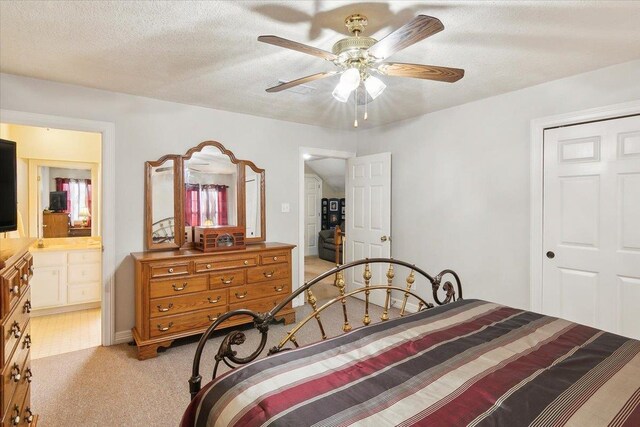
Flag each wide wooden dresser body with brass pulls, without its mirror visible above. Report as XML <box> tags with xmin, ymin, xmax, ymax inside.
<box><xmin>131</xmin><ymin>243</ymin><xmax>295</xmax><ymax>360</ymax></box>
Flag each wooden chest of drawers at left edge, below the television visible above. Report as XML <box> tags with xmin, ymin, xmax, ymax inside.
<box><xmin>0</xmin><ymin>239</ymin><xmax>37</xmax><ymax>426</ymax></box>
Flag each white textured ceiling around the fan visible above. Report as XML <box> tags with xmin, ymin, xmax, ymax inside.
<box><xmin>0</xmin><ymin>0</ymin><xmax>640</xmax><ymax>128</ymax></box>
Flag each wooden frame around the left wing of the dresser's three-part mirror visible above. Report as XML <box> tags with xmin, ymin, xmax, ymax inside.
<box><xmin>144</xmin><ymin>154</ymin><xmax>184</xmax><ymax>250</ymax></box>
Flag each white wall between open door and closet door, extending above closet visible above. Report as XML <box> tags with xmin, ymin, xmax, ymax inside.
<box><xmin>357</xmin><ymin>61</ymin><xmax>640</xmax><ymax>308</ymax></box>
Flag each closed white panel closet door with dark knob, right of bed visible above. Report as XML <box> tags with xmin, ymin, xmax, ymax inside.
<box><xmin>542</xmin><ymin>116</ymin><xmax>640</xmax><ymax>338</ymax></box>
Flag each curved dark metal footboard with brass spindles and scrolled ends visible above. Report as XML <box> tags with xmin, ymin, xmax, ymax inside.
<box><xmin>189</xmin><ymin>258</ymin><xmax>462</xmax><ymax>399</ymax></box>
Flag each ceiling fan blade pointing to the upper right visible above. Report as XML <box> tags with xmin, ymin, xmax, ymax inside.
<box><xmin>369</xmin><ymin>15</ymin><xmax>444</xmax><ymax>59</ymax></box>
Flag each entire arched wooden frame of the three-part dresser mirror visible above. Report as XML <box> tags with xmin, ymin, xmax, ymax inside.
<box><xmin>145</xmin><ymin>140</ymin><xmax>267</xmax><ymax>251</ymax></box>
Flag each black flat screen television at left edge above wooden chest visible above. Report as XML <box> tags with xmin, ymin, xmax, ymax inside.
<box><xmin>0</xmin><ymin>139</ymin><xmax>18</xmax><ymax>233</ymax></box>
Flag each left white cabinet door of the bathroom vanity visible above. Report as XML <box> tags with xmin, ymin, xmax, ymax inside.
<box><xmin>31</xmin><ymin>264</ymin><xmax>67</xmax><ymax>309</ymax></box>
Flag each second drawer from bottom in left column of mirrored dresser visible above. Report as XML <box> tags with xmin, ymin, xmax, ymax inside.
<box><xmin>149</xmin><ymin>289</ymin><xmax>227</xmax><ymax>318</ymax></box>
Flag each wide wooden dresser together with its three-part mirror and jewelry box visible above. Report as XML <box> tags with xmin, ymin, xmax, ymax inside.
<box><xmin>131</xmin><ymin>141</ymin><xmax>295</xmax><ymax>360</ymax></box>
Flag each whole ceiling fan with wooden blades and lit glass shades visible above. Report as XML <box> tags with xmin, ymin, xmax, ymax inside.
<box><xmin>258</xmin><ymin>14</ymin><xmax>464</xmax><ymax>127</ymax></box>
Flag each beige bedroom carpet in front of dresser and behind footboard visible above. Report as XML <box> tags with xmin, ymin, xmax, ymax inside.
<box><xmin>31</xmin><ymin>298</ymin><xmax>397</xmax><ymax>427</ymax></box>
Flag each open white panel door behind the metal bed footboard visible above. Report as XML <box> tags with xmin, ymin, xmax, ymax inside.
<box><xmin>345</xmin><ymin>153</ymin><xmax>391</xmax><ymax>305</ymax></box>
